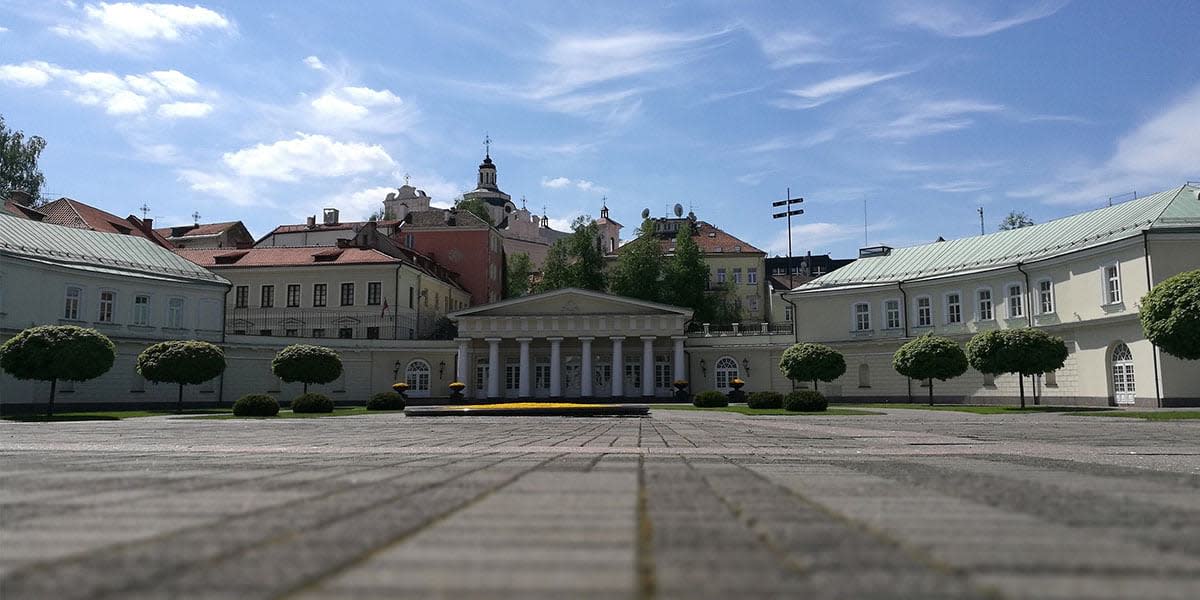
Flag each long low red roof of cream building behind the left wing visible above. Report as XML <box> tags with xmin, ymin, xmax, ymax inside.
<box><xmin>175</xmin><ymin>246</ymin><xmax>403</xmax><ymax>269</ymax></box>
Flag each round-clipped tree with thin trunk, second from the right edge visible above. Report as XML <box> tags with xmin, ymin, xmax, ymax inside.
<box><xmin>967</xmin><ymin>328</ymin><xmax>1069</xmax><ymax>408</ymax></box>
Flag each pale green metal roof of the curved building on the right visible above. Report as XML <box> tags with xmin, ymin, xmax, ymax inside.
<box><xmin>796</xmin><ymin>184</ymin><xmax>1200</xmax><ymax>292</ymax></box>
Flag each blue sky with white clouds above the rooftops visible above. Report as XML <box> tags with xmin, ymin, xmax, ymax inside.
<box><xmin>0</xmin><ymin>0</ymin><xmax>1200</xmax><ymax>256</ymax></box>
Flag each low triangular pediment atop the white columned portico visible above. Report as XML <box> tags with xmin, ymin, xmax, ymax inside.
<box><xmin>450</xmin><ymin>288</ymin><xmax>692</xmax><ymax>319</ymax></box>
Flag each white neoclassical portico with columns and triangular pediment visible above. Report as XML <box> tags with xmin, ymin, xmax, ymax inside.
<box><xmin>450</xmin><ymin>288</ymin><xmax>691</xmax><ymax>398</ymax></box>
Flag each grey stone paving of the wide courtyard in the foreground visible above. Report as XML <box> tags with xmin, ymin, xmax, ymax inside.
<box><xmin>0</xmin><ymin>409</ymin><xmax>1200</xmax><ymax>600</ymax></box>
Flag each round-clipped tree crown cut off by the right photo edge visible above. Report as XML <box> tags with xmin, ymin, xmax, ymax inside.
<box><xmin>1141</xmin><ymin>270</ymin><xmax>1200</xmax><ymax>360</ymax></box>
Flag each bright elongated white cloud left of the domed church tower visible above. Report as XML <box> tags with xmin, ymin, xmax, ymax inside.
<box><xmin>222</xmin><ymin>132</ymin><xmax>395</xmax><ymax>181</ymax></box>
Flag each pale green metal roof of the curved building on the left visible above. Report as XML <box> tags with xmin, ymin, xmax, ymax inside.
<box><xmin>0</xmin><ymin>215</ymin><xmax>229</xmax><ymax>284</ymax></box>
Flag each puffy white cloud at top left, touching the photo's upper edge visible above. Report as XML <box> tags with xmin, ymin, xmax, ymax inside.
<box><xmin>52</xmin><ymin>2</ymin><xmax>233</xmax><ymax>52</ymax></box>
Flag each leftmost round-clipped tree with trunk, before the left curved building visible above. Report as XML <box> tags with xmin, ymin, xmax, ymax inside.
<box><xmin>0</xmin><ymin>325</ymin><xmax>116</xmax><ymax>415</ymax></box>
